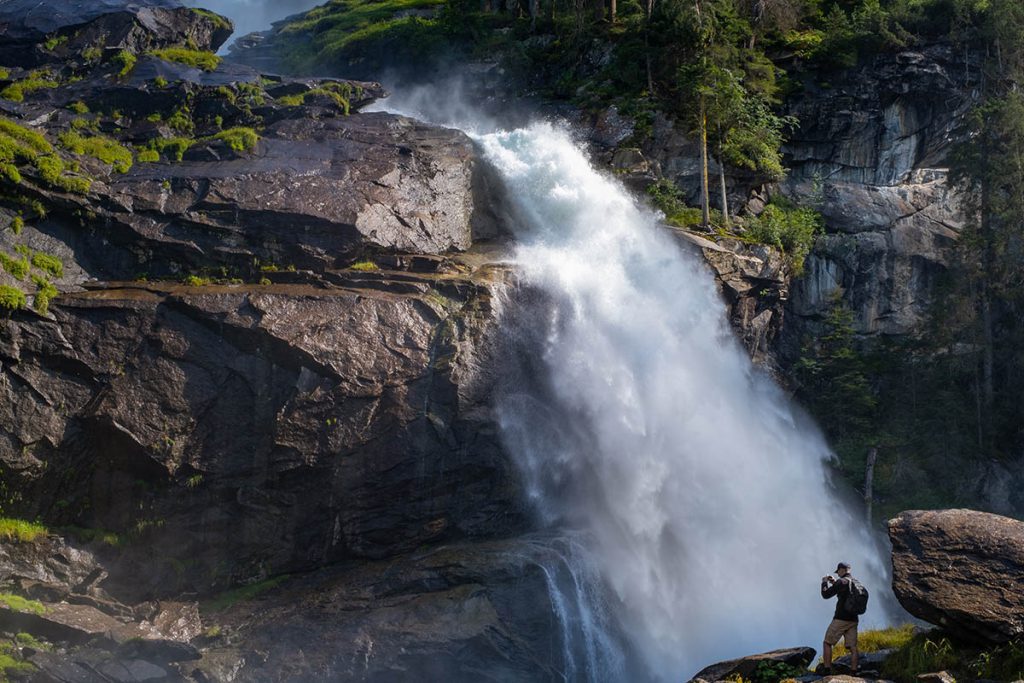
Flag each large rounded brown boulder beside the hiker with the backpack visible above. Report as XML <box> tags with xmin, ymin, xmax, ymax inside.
<box><xmin>889</xmin><ymin>510</ymin><xmax>1024</xmax><ymax>643</ymax></box>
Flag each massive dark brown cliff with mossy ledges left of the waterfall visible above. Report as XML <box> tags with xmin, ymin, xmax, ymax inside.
<box><xmin>0</xmin><ymin>0</ymin><xmax>598</xmax><ymax>681</ymax></box>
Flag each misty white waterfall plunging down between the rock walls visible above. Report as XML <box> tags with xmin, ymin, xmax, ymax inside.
<box><xmin>374</xmin><ymin>90</ymin><xmax>886</xmax><ymax>680</ymax></box>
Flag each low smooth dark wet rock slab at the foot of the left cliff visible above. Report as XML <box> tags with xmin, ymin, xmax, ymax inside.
<box><xmin>182</xmin><ymin>536</ymin><xmax>622</xmax><ymax>681</ymax></box>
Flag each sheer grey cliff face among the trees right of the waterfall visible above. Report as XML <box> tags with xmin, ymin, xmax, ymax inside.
<box><xmin>783</xmin><ymin>45</ymin><xmax>980</xmax><ymax>344</ymax></box>
